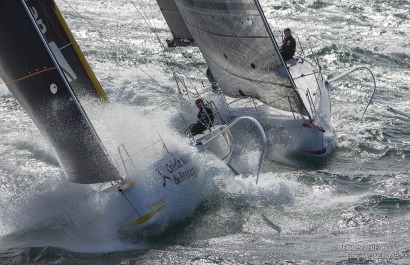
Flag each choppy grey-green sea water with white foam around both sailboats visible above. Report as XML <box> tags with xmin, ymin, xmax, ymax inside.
<box><xmin>0</xmin><ymin>0</ymin><xmax>410</xmax><ymax>264</ymax></box>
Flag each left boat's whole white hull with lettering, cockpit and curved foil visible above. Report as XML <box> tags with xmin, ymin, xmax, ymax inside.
<box><xmin>109</xmin><ymin>117</ymin><xmax>266</xmax><ymax>233</ymax></box>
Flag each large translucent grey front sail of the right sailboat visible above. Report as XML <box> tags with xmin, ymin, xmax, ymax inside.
<box><xmin>175</xmin><ymin>0</ymin><xmax>307</xmax><ymax>114</ymax></box>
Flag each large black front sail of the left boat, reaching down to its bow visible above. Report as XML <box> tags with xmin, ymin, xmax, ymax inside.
<box><xmin>0</xmin><ymin>0</ymin><xmax>119</xmax><ymax>184</ymax></box>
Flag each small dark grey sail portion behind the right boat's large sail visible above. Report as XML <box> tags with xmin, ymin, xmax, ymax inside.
<box><xmin>157</xmin><ymin>0</ymin><xmax>192</xmax><ymax>40</ymax></box>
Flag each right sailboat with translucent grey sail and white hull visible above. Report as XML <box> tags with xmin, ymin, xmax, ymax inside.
<box><xmin>156</xmin><ymin>0</ymin><xmax>374</xmax><ymax>157</ymax></box>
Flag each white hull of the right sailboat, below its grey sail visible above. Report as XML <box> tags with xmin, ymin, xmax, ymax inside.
<box><xmin>205</xmin><ymin>59</ymin><xmax>333</xmax><ymax>156</ymax></box>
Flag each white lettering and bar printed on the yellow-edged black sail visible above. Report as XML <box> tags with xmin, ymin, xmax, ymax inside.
<box><xmin>25</xmin><ymin>0</ymin><xmax>77</xmax><ymax>82</ymax></box>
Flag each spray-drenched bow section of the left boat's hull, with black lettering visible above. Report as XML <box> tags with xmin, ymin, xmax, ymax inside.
<box><xmin>107</xmin><ymin>153</ymin><xmax>212</xmax><ymax>233</ymax></box>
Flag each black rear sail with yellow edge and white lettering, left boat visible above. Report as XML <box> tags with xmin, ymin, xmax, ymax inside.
<box><xmin>25</xmin><ymin>0</ymin><xmax>108</xmax><ymax>101</ymax></box>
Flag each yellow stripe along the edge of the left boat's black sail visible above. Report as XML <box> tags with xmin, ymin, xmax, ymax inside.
<box><xmin>54</xmin><ymin>5</ymin><xmax>109</xmax><ymax>102</ymax></box>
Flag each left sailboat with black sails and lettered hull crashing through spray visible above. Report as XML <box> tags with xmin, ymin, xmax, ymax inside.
<box><xmin>0</xmin><ymin>0</ymin><xmax>266</xmax><ymax>229</ymax></box>
